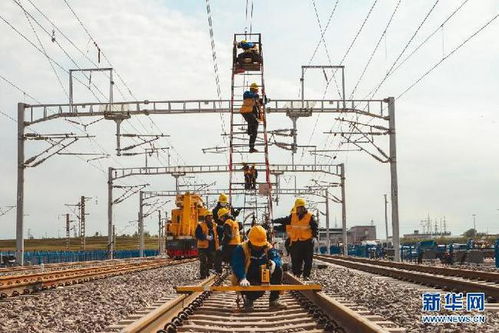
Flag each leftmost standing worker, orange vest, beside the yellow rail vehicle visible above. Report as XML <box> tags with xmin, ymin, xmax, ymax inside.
<box><xmin>195</xmin><ymin>209</ymin><xmax>222</xmax><ymax>279</ymax></box>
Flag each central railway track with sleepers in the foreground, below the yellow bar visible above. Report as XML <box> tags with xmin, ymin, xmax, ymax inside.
<box><xmin>108</xmin><ymin>274</ymin><xmax>406</xmax><ymax>333</ymax></box>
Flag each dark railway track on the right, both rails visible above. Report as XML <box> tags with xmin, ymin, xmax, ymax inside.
<box><xmin>315</xmin><ymin>255</ymin><xmax>499</xmax><ymax>301</ymax></box>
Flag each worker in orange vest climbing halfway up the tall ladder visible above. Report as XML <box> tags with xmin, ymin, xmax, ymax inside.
<box><xmin>239</xmin><ymin>83</ymin><xmax>263</xmax><ymax>153</ymax></box>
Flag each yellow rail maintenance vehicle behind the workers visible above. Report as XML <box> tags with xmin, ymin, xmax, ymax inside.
<box><xmin>165</xmin><ymin>192</ymin><xmax>207</xmax><ymax>258</ymax></box>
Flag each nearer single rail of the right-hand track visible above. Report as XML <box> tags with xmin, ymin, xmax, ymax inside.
<box><xmin>316</xmin><ymin>255</ymin><xmax>499</xmax><ymax>300</ymax></box>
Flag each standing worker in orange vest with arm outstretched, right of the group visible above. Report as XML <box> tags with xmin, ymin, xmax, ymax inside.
<box><xmin>273</xmin><ymin>198</ymin><xmax>318</xmax><ymax>280</ymax></box>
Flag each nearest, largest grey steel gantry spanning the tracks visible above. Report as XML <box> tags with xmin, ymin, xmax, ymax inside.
<box><xmin>16</xmin><ymin>97</ymin><xmax>400</xmax><ymax>265</ymax></box>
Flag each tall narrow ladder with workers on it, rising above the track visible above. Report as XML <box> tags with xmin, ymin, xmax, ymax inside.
<box><xmin>229</xmin><ymin>33</ymin><xmax>272</xmax><ymax>227</ymax></box>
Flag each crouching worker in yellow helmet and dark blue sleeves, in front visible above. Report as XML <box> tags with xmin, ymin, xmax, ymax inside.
<box><xmin>231</xmin><ymin>225</ymin><xmax>286</xmax><ymax>311</ymax></box>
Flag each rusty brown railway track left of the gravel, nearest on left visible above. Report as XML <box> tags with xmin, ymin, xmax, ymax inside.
<box><xmin>0</xmin><ymin>258</ymin><xmax>194</xmax><ymax>298</ymax></box>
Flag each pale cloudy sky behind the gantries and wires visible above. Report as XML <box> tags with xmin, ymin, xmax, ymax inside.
<box><xmin>0</xmin><ymin>0</ymin><xmax>499</xmax><ymax>239</ymax></box>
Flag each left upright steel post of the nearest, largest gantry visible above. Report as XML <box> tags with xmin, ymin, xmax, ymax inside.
<box><xmin>16</xmin><ymin>103</ymin><xmax>25</xmax><ymax>266</ymax></box>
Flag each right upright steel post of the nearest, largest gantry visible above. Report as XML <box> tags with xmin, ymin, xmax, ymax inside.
<box><xmin>388</xmin><ymin>97</ymin><xmax>400</xmax><ymax>261</ymax></box>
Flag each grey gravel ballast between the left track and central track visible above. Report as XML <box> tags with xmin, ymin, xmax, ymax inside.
<box><xmin>0</xmin><ymin>262</ymin><xmax>199</xmax><ymax>332</ymax></box>
